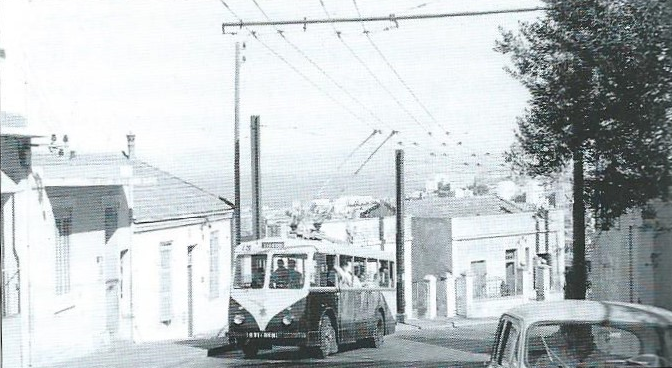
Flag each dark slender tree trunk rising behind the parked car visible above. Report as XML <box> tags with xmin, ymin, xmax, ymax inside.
<box><xmin>565</xmin><ymin>146</ymin><xmax>588</xmax><ymax>299</ymax></box>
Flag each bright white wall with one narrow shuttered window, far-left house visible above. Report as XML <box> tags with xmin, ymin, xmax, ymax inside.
<box><xmin>22</xmin><ymin>180</ymin><xmax>128</xmax><ymax>365</ymax></box>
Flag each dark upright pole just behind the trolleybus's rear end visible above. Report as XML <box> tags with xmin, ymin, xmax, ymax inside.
<box><xmin>395</xmin><ymin>149</ymin><xmax>406</xmax><ymax>323</ymax></box>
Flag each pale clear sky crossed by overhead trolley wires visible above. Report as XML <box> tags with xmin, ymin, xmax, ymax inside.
<box><xmin>0</xmin><ymin>0</ymin><xmax>542</xmax><ymax>205</ymax></box>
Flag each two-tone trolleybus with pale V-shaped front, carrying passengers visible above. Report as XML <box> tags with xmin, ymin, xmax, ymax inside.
<box><xmin>228</xmin><ymin>237</ymin><xmax>396</xmax><ymax>358</ymax></box>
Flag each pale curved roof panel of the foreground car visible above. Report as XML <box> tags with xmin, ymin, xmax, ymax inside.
<box><xmin>505</xmin><ymin>300</ymin><xmax>672</xmax><ymax>326</ymax></box>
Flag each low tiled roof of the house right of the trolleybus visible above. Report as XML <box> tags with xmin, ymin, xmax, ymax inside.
<box><xmin>406</xmin><ymin>195</ymin><xmax>527</xmax><ymax>218</ymax></box>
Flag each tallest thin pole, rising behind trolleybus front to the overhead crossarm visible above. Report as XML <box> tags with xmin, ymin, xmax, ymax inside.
<box><xmin>231</xmin><ymin>42</ymin><xmax>240</xmax><ymax>256</ymax></box>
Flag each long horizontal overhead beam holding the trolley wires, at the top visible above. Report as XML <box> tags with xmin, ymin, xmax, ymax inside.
<box><xmin>222</xmin><ymin>7</ymin><xmax>546</xmax><ymax>28</ymax></box>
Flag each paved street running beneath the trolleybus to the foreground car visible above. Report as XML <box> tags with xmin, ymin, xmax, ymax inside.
<box><xmin>40</xmin><ymin>320</ymin><xmax>496</xmax><ymax>368</ymax></box>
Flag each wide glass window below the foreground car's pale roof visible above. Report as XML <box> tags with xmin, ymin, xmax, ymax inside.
<box><xmin>526</xmin><ymin>322</ymin><xmax>672</xmax><ymax>367</ymax></box>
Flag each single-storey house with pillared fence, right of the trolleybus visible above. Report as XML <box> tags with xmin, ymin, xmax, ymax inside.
<box><xmin>409</xmin><ymin>196</ymin><xmax>565</xmax><ymax>318</ymax></box>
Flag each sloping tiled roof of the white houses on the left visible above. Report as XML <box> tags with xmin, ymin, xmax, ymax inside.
<box><xmin>33</xmin><ymin>152</ymin><xmax>232</xmax><ymax>223</ymax></box>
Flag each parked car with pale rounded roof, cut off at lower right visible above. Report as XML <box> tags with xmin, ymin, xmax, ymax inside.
<box><xmin>487</xmin><ymin>300</ymin><xmax>672</xmax><ymax>368</ymax></box>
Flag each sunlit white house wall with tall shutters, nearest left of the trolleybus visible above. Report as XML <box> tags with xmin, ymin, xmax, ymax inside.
<box><xmin>131</xmin><ymin>219</ymin><xmax>231</xmax><ymax>341</ymax></box>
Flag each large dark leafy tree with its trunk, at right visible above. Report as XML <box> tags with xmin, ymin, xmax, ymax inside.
<box><xmin>495</xmin><ymin>0</ymin><xmax>672</xmax><ymax>299</ymax></box>
